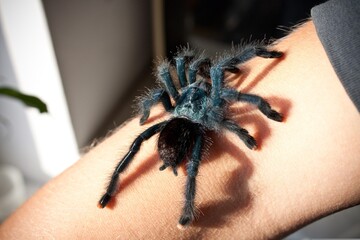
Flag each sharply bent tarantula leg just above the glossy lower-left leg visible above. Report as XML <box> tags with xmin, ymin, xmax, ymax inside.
<box><xmin>140</xmin><ymin>89</ymin><xmax>174</xmax><ymax>125</ymax></box>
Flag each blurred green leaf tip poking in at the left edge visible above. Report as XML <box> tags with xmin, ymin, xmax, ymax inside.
<box><xmin>0</xmin><ymin>87</ymin><xmax>48</xmax><ymax>113</ymax></box>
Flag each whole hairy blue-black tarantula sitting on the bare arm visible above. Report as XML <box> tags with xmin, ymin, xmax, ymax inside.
<box><xmin>98</xmin><ymin>45</ymin><xmax>283</xmax><ymax>227</ymax></box>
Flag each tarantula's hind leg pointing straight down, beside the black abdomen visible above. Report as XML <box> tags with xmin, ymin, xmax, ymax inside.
<box><xmin>178</xmin><ymin>134</ymin><xmax>204</xmax><ymax>228</ymax></box>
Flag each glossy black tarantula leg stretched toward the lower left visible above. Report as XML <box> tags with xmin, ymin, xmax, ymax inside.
<box><xmin>98</xmin><ymin>121</ymin><xmax>168</xmax><ymax>208</ymax></box>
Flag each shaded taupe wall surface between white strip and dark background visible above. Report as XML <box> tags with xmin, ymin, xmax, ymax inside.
<box><xmin>43</xmin><ymin>0</ymin><xmax>152</xmax><ymax>146</ymax></box>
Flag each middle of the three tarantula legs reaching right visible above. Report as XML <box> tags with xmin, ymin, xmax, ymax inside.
<box><xmin>221</xmin><ymin>89</ymin><xmax>283</xmax><ymax>122</ymax></box>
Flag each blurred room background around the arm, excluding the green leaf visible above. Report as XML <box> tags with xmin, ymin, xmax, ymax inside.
<box><xmin>0</xmin><ymin>0</ymin><xmax>360</xmax><ymax>236</ymax></box>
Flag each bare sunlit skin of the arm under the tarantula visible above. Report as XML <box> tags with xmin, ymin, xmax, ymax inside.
<box><xmin>0</xmin><ymin>22</ymin><xmax>360</xmax><ymax>239</ymax></box>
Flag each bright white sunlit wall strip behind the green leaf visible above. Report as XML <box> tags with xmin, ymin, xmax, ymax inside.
<box><xmin>0</xmin><ymin>0</ymin><xmax>78</xmax><ymax>182</ymax></box>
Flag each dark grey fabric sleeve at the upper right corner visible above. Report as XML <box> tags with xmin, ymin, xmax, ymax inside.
<box><xmin>311</xmin><ymin>0</ymin><xmax>360</xmax><ymax>112</ymax></box>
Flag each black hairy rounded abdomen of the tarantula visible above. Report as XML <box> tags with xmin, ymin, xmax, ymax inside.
<box><xmin>158</xmin><ymin>118</ymin><xmax>201</xmax><ymax>175</ymax></box>
